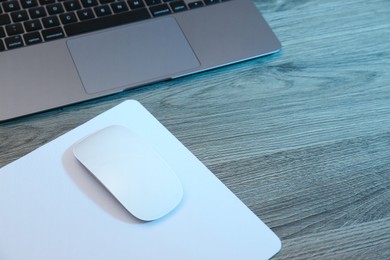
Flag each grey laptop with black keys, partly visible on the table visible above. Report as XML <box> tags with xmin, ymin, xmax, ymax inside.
<box><xmin>0</xmin><ymin>0</ymin><xmax>280</xmax><ymax>121</ymax></box>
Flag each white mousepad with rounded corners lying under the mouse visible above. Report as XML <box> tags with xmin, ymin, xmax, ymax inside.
<box><xmin>0</xmin><ymin>100</ymin><xmax>281</xmax><ymax>260</ymax></box>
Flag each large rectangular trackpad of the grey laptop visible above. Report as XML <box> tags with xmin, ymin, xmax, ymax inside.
<box><xmin>67</xmin><ymin>17</ymin><xmax>200</xmax><ymax>94</ymax></box>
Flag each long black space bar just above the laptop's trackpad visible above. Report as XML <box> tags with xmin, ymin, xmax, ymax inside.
<box><xmin>64</xmin><ymin>9</ymin><xmax>150</xmax><ymax>36</ymax></box>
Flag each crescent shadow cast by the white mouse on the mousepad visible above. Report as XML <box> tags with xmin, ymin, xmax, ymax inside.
<box><xmin>62</xmin><ymin>146</ymin><xmax>144</xmax><ymax>224</ymax></box>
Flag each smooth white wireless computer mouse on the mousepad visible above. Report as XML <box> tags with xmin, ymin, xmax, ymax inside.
<box><xmin>73</xmin><ymin>125</ymin><xmax>183</xmax><ymax>221</ymax></box>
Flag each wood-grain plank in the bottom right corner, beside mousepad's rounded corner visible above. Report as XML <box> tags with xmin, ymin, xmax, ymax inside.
<box><xmin>274</xmin><ymin>218</ymin><xmax>390</xmax><ymax>260</ymax></box>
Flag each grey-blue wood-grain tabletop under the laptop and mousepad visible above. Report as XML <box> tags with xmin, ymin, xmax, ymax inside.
<box><xmin>0</xmin><ymin>0</ymin><xmax>390</xmax><ymax>259</ymax></box>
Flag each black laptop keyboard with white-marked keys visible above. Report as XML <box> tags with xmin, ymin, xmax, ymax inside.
<box><xmin>0</xmin><ymin>0</ymin><xmax>224</xmax><ymax>51</ymax></box>
